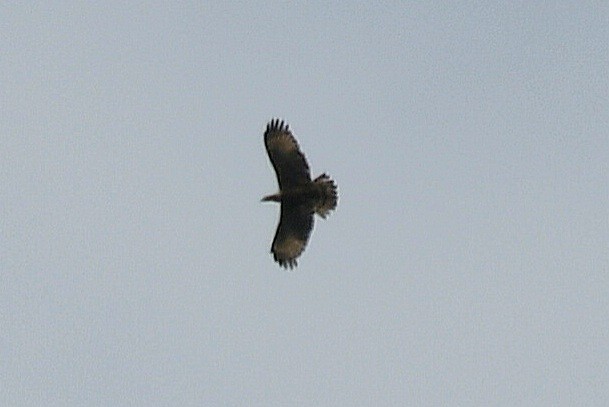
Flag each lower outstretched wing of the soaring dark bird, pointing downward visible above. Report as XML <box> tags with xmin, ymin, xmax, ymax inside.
<box><xmin>271</xmin><ymin>204</ymin><xmax>313</xmax><ymax>269</ymax></box>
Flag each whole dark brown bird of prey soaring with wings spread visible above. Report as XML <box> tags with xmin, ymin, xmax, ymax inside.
<box><xmin>262</xmin><ymin>119</ymin><xmax>338</xmax><ymax>269</ymax></box>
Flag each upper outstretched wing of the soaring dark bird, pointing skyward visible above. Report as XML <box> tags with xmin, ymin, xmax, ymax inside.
<box><xmin>264</xmin><ymin>119</ymin><xmax>311</xmax><ymax>189</ymax></box>
